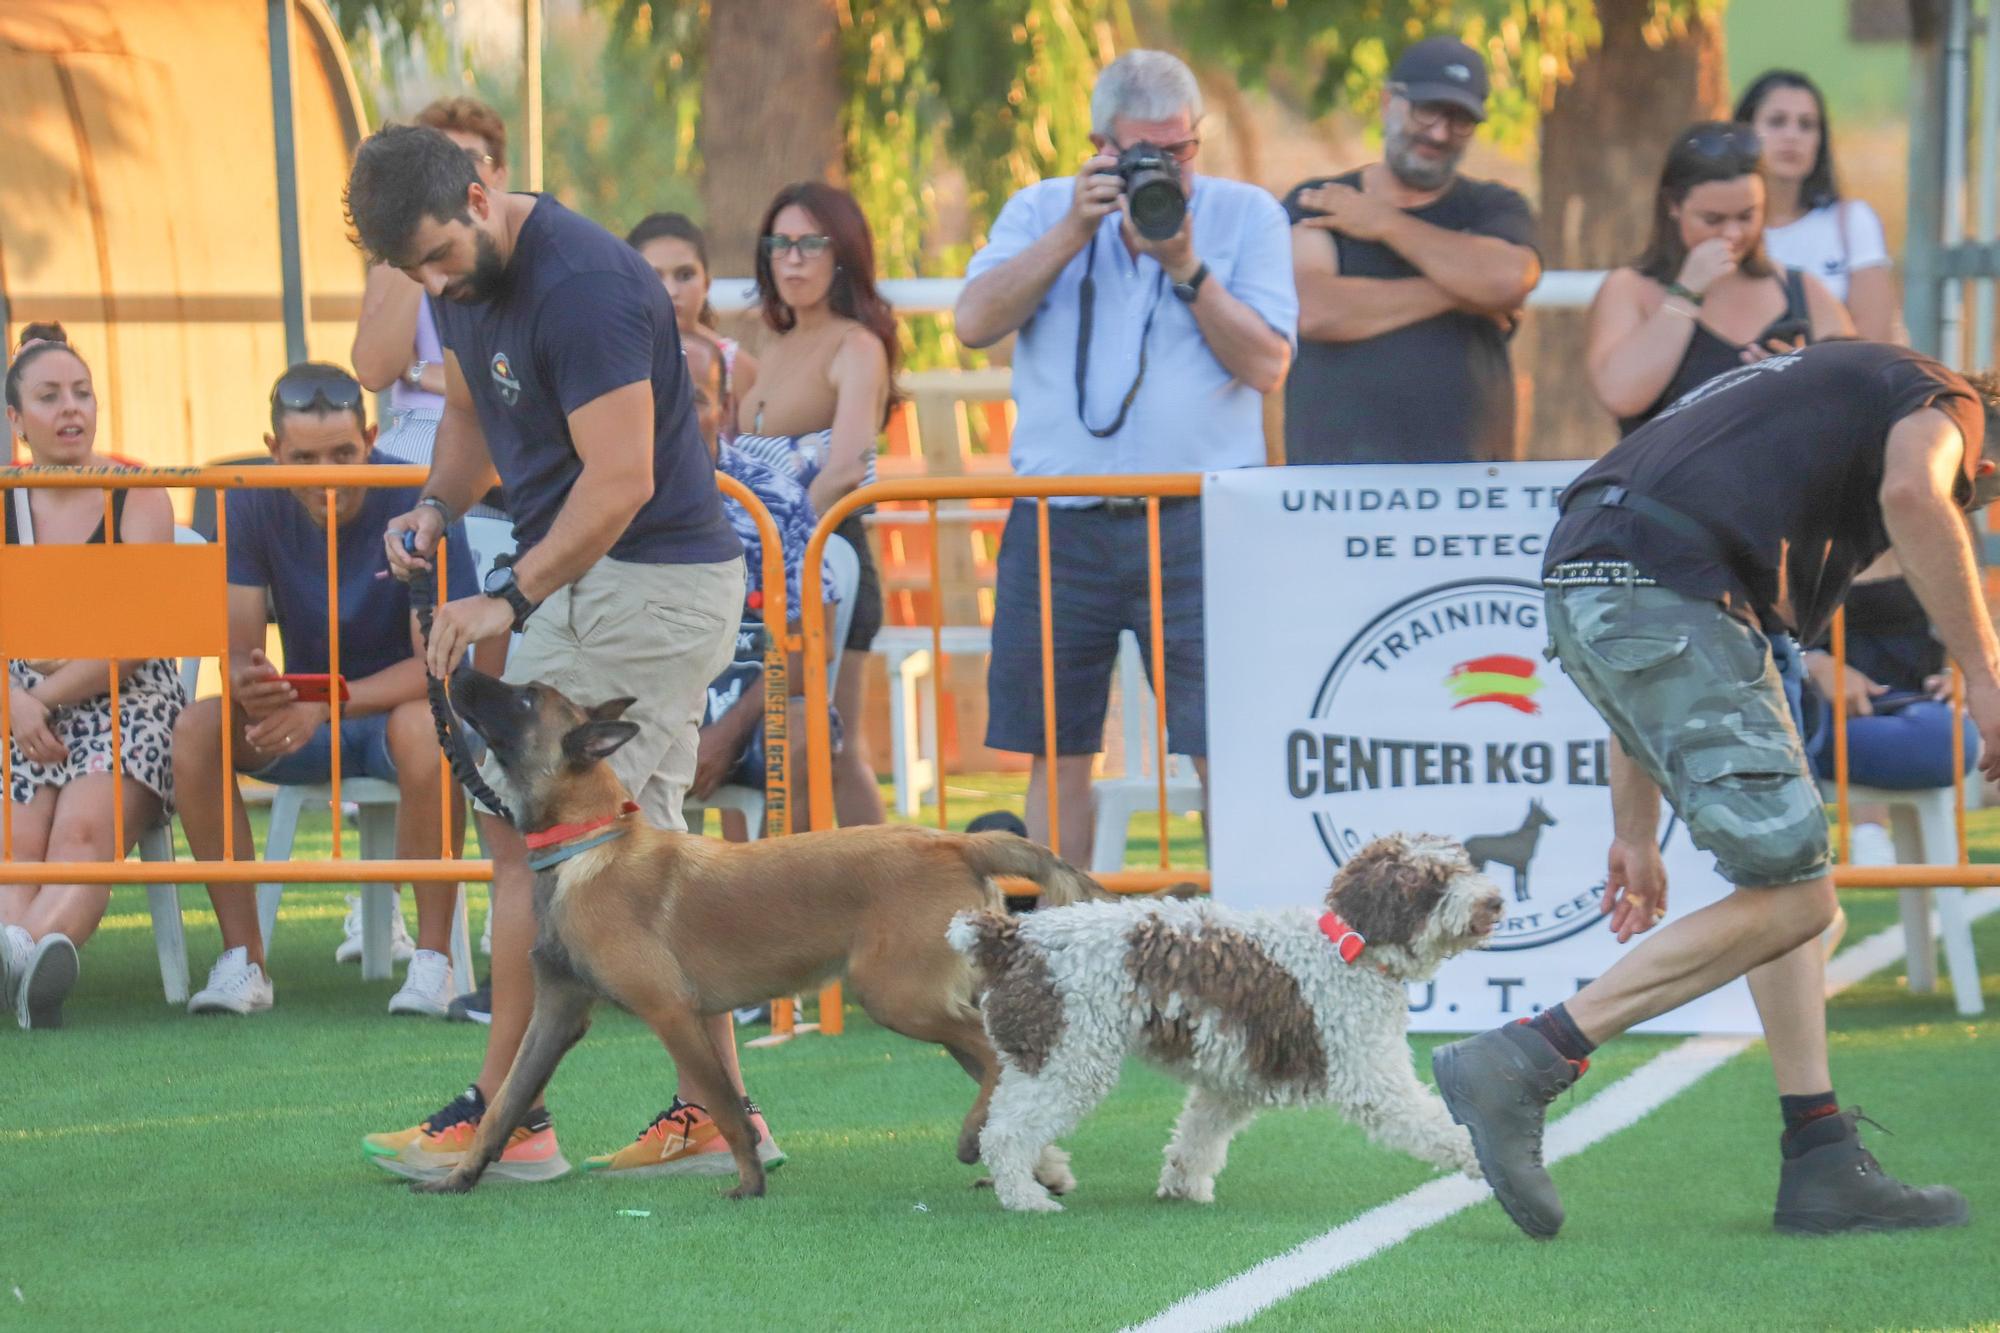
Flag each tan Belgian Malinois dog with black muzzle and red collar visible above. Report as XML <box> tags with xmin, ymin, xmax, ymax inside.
<box><xmin>414</xmin><ymin>669</ymin><xmax>1104</xmax><ymax>1199</ymax></box>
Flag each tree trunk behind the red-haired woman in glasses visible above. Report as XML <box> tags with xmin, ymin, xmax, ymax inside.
<box><xmin>698</xmin><ymin>0</ymin><xmax>844</xmax><ymax>276</ymax></box>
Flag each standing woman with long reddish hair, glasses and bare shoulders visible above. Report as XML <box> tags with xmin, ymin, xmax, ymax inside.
<box><xmin>734</xmin><ymin>182</ymin><xmax>900</xmax><ymax>825</ymax></box>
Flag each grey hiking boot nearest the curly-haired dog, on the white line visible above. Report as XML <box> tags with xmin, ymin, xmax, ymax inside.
<box><xmin>1430</xmin><ymin>1023</ymin><xmax>1588</xmax><ymax>1241</ymax></box>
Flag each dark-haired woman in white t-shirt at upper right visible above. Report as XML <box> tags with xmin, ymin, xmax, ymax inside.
<box><xmin>1736</xmin><ymin>70</ymin><xmax>1902</xmax><ymax>342</ymax></box>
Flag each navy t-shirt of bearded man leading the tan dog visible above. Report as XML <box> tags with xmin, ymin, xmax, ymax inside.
<box><xmin>432</xmin><ymin>194</ymin><xmax>742</xmax><ymax>564</ymax></box>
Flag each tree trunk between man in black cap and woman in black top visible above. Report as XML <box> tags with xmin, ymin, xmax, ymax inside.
<box><xmin>1522</xmin><ymin>0</ymin><xmax>1728</xmax><ymax>458</ymax></box>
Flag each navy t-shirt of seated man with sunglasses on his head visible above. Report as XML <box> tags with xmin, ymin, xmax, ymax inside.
<box><xmin>224</xmin><ymin>452</ymin><xmax>478</xmax><ymax>681</ymax></box>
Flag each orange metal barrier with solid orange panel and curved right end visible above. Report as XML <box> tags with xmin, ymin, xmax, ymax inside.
<box><xmin>0</xmin><ymin>464</ymin><xmax>792</xmax><ymax>885</ymax></box>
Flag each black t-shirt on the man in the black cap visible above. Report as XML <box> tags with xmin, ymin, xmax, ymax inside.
<box><xmin>1284</xmin><ymin>172</ymin><xmax>1534</xmax><ymax>462</ymax></box>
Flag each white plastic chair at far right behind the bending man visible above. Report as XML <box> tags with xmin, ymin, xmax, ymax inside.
<box><xmin>1820</xmin><ymin>773</ymin><xmax>1986</xmax><ymax>1015</ymax></box>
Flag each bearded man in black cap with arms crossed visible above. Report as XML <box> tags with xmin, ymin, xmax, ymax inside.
<box><xmin>1284</xmin><ymin>36</ymin><xmax>1542</xmax><ymax>462</ymax></box>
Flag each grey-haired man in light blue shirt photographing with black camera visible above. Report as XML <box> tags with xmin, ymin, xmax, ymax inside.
<box><xmin>956</xmin><ymin>50</ymin><xmax>1298</xmax><ymax>855</ymax></box>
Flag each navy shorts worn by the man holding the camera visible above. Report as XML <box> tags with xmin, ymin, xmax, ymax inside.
<box><xmin>986</xmin><ymin>496</ymin><xmax>1208</xmax><ymax>757</ymax></box>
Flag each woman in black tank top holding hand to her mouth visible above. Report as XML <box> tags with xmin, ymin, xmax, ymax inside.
<box><xmin>1586</xmin><ymin>120</ymin><xmax>1854</xmax><ymax>434</ymax></box>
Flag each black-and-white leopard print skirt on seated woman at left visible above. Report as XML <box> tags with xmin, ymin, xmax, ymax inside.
<box><xmin>8</xmin><ymin>656</ymin><xmax>188</xmax><ymax>813</ymax></box>
